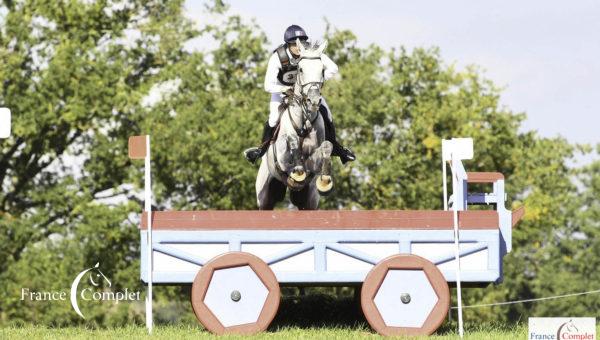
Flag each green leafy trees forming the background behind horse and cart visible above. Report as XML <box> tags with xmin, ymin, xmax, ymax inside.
<box><xmin>0</xmin><ymin>0</ymin><xmax>600</xmax><ymax>325</ymax></box>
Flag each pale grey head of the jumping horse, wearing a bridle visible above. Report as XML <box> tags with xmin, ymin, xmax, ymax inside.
<box><xmin>296</xmin><ymin>40</ymin><xmax>327</xmax><ymax>113</ymax></box>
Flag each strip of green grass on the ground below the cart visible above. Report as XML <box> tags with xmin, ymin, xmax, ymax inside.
<box><xmin>0</xmin><ymin>326</ymin><xmax>527</xmax><ymax>340</ymax></box>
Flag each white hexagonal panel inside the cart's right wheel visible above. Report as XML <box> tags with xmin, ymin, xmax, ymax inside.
<box><xmin>374</xmin><ymin>269</ymin><xmax>438</xmax><ymax>327</ymax></box>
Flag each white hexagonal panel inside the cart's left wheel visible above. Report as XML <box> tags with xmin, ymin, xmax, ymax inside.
<box><xmin>204</xmin><ymin>266</ymin><xmax>269</xmax><ymax>327</ymax></box>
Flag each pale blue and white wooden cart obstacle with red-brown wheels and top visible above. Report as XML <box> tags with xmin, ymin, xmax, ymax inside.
<box><xmin>130</xmin><ymin>138</ymin><xmax>523</xmax><ymax>335</ymax></box>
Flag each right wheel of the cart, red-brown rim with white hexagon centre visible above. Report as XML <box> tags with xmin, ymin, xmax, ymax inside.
<box><xmin>361</xmin><ymin>255</ymin><xmax>450</xmax><ymax>335</ymax></box>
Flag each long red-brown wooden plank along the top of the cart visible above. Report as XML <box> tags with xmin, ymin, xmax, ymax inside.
<box><xmin>141</xmin><ymin>210</ymin><xmax>498</xmax><ymax>230</ymax></box>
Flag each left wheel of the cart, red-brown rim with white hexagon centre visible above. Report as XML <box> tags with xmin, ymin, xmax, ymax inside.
<box><xmin>192</xmin><ymin>252</ymin><xmax>280</xmax><ymax>334</ymax></box>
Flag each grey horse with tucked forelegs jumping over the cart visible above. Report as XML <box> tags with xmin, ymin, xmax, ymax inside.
<box><xmin>256</xmin><ymin>41</ymin><xmax>333</xmax><ymax>210</ymax></box>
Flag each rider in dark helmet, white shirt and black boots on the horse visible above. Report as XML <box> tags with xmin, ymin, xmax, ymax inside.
<box><xmin>244</xmin><ymin>25</ymin><xmax>356</xmax><ymax>164</ymax></box>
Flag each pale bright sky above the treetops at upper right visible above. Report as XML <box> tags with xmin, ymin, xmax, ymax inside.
<box><xmin>186</xmin><ymin>0</ymin><xmax>600</xmax><ymax>144</ymax></box>
